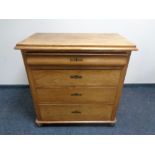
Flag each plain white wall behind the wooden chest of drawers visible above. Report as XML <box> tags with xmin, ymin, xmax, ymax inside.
<box><xmin>0</xmin><ymin>20</ymin><xmax>155</xmax><ymax>84</ymax></box>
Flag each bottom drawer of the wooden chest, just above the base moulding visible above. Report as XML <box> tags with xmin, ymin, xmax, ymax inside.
<box><xmin>39</xmin><ymin>104</ymin><xmax>113</xmax><ymax>121</ymax></box>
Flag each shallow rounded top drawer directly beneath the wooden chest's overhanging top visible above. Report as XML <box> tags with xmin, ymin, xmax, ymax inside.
<box><xmin>26</xmin><ymin>53</ymin><xmax>128</xmax><ymax>66</ymax></box>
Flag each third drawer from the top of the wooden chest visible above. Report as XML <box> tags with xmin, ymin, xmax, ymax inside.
<box><xmin>36</xmin><ymin>87</ymin><xmax>116</xmax><ymax>104</ymax></box>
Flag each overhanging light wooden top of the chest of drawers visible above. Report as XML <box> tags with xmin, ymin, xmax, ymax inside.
<box><xmin>16</xmin><ymin>33</ymin><xmax>137</xmax><ymax>51</ymax></box>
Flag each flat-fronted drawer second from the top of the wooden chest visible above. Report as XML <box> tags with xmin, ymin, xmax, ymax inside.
<box><xmin>32</xmin><ymin>70</ymin><xmax>121</xmax><ymax>88</ymax></box>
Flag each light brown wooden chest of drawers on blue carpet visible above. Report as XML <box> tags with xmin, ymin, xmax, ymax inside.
<box><xmin>16</xmin><ymin>33</ymin><xmax>137</xmax><ymax>125</ymax></box>
